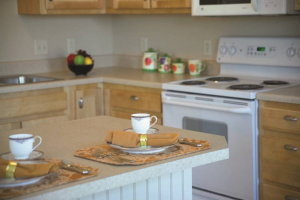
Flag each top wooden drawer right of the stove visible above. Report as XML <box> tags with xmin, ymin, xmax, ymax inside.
<box><xmin>261</xmin><ymin>108</ymin><xmax>300</xmax><ymax>134</ymax></box>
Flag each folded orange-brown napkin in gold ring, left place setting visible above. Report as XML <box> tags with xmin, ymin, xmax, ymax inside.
<box><xmin>0</xmin><ymin>158</ymin><xmax>59</xmax><ymax>178</ymax></box>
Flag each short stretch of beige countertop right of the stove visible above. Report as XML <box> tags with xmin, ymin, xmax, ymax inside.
<box><xmin>257</xmin><ymin>86</ymin><xmax>300</xmax><ymax>104</ymax></box>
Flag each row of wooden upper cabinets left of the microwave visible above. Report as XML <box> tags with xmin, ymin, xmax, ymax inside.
<box><xmin>18</xmin><ymin>0</ymin><xmax>191</xmax><ymax>15</ymax></box>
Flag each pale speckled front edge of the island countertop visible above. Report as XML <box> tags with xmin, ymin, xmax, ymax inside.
<box><xmin>24</xmin><ymin>148</ymin><xmax>229</xmax><ymax>200</ymax></box>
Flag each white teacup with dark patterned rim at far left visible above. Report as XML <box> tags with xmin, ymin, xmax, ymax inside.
<box><xmin>9</xmin><ymin>133</ymin><xmax>42</xmax><ymax>159</ymax></box>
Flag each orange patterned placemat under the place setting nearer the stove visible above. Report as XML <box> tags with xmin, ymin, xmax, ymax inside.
<box><xmin>74</xmin><ymin>140</ymin><xmax>210</xmax><ymax>165</ymax></box>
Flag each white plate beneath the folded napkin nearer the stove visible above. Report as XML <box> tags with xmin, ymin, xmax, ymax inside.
<box><xmin>107</xmin><ymin>143</ymin><xmax>175</xmax><ymax>154</ymax></box>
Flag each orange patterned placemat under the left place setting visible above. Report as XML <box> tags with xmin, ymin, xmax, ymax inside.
<box><xmin>0</xmin><ymin>159</ymin><xmax>99</xmax><ymax>199</ymax></box>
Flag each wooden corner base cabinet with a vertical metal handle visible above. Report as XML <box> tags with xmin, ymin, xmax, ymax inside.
<box><xmin>69</xmin><ymin>84</ymin><xmax>102</xmax><ymax>119</ymax></box>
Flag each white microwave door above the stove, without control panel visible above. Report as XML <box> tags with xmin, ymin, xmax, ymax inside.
<box><xmin>192</xmin><ymin>0</ymin><xmax>261</xmax><ymax>16</ymax></box>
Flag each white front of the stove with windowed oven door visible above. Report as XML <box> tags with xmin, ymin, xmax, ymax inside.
<box><xmin>162</xmin><ymin>92</ymin><xmax>258</xmax><ymax>200</ymax></box>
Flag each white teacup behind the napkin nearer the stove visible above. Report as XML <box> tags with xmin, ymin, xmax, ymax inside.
<box><xmin>131</xmin><ymin>113</ymin><xmax>157</xmax><ymax>134</ymax></box>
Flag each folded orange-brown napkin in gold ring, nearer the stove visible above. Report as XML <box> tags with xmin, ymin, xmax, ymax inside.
<box><xmin>105</xmin><ymin>131</ymin><xmax>179</xmax><ymax>147</ymax></box>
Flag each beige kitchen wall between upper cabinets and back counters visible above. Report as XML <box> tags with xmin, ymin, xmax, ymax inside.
<box><xmin>0</xmin><ymin>0</ymin><xmax>300</xmax><ymax>75</ymax></box>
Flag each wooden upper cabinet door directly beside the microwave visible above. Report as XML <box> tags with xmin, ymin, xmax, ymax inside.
<box><xmin>151</xmin><ymin>0</ymin><xmax>191</xmax><ymax>9</ymax></box>
